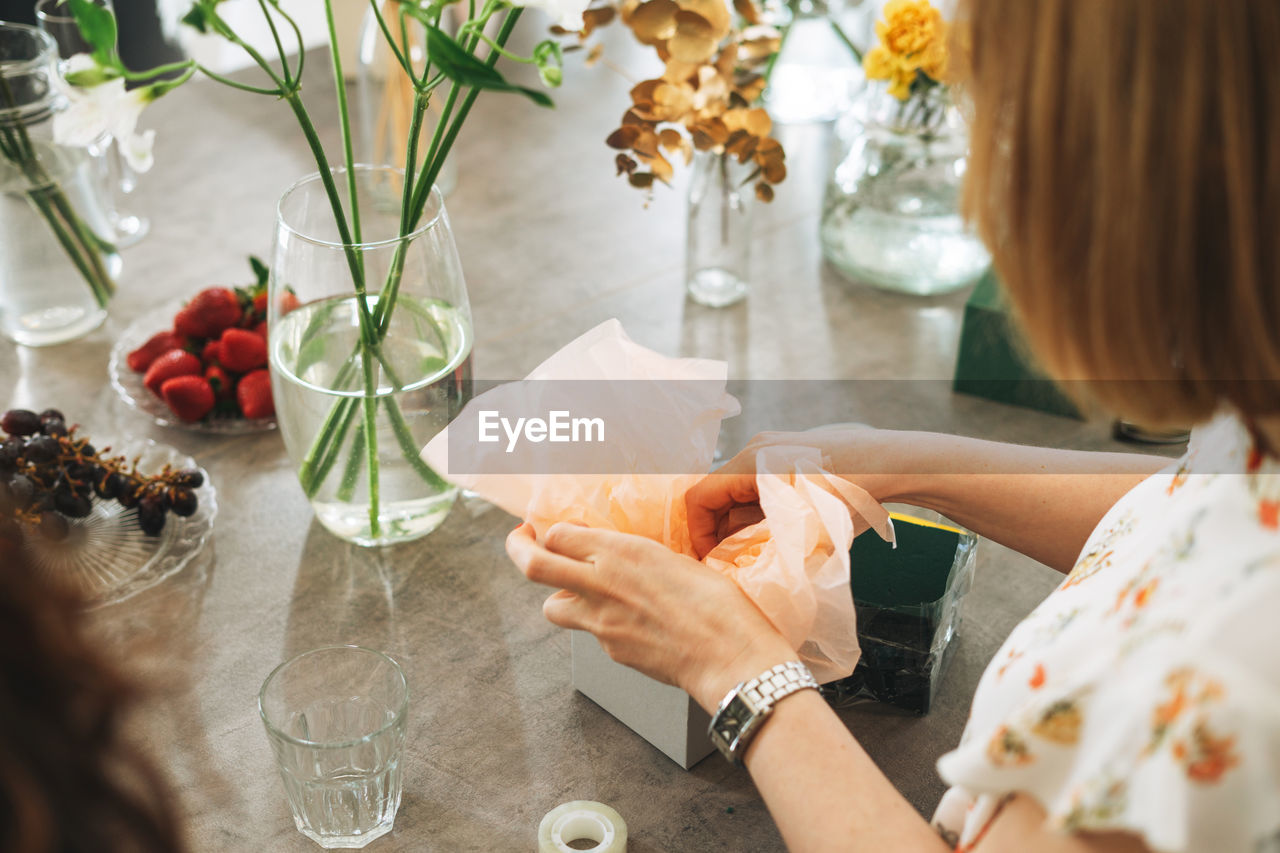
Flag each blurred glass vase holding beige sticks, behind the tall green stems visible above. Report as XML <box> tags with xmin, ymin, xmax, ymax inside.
<box><xmin>356</xmin><ymin>6</ymin><xmax>458</xmax><ymax>196</ymax></box>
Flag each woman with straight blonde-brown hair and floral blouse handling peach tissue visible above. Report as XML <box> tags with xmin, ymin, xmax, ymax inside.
<box><xmin>508</xmin><ymin>0</ymin><xmax>1280</xmax><ymax>852</ymax></box>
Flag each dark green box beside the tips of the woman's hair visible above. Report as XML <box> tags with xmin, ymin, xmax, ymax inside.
<box><xmin>951</xmin><ymin>272</ymin><xmax>1084</xmax><ymax>420</ymax></box>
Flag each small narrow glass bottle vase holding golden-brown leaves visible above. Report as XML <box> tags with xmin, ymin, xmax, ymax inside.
<box><xmin>685</xmin><ymin>151</ymin><xmax>755</xmax><ymax>307</ymax></box>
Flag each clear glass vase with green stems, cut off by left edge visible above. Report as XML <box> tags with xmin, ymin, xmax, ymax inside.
<box><xmin>0</xmin><ymin>23</ymin><xmax>120</xmax><ymax>346</ymax></box>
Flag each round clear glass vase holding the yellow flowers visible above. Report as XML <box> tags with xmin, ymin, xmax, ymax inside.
<box><xmin>819</xmin><ymin>86</ymin><xmax>991</xmax><ymax>296</ymax></box>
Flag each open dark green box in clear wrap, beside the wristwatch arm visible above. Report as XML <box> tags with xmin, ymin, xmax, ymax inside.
<box><xmin>822</xmin><ymin>514</ymin><xmax>978</xmax><ymax>713</ymax></box>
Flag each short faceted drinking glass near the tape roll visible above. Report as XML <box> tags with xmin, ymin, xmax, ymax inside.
<box><xmin>257</xmin><ymin>646</ymin><xmax>408</xmax><ymax>849</ymax></box>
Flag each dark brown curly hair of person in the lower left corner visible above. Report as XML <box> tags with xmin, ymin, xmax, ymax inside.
<box><xmin>0</xmin><ymin>532</ymin><xmax>186</xmax><ymax>853</ymax></box>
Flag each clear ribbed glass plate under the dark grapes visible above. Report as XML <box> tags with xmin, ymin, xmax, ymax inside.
<box><xmin>23</xmin><ymin>439</ymin><xmax>218</xmax><ymax>607</ymax></box>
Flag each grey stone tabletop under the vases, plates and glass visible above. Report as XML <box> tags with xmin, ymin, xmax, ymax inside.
<box><xmin>0</xmin><ymin>31</ymin><xmax>1177</xmax><ymax>853</ymax></box>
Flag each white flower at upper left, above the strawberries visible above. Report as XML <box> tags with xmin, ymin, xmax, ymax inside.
<box><xmin>54</xmin><ymin>54</ymin><xmax>156</xmax><ymax>172</ymax></box>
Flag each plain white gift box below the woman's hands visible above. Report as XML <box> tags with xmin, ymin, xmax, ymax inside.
<box><xmin>570</xmin><ymin>631</ymin><xmax>716</xmax><ymax>770</ymax></box>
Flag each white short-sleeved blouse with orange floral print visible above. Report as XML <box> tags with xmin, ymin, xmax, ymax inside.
<box><xmin>933</xmin><ymin>415</ymin><xmax>1280</xmax><ymax>853</ymax></box>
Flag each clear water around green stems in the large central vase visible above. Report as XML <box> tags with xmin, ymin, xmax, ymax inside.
<box><xmin>270</xmin><ymin>295</ymin><xmax>471</xmax><ymax>544</ymax></box>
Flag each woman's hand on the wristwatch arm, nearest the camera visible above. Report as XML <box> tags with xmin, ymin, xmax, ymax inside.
<box><xmin>507</xmin><ymin>524</ymin><xmax>796</xmax><ymax>711</ymax></box>
